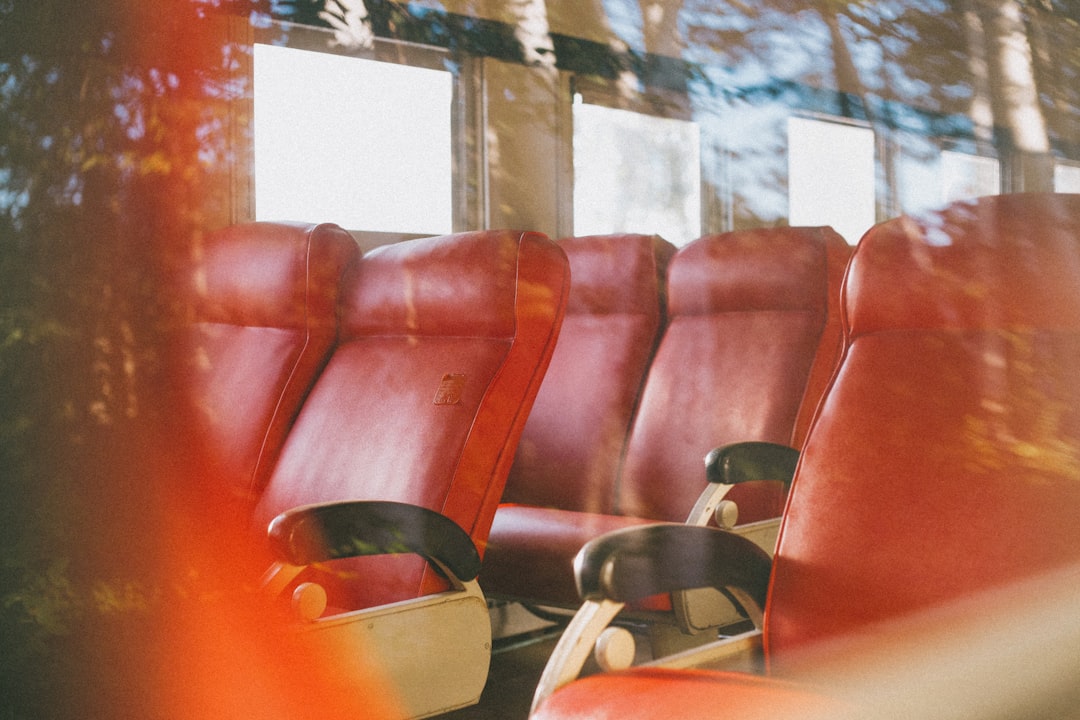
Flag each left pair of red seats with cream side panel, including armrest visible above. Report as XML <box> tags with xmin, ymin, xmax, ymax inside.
<box><xmin>170</xmin><ymin>222</ymin><xmax>569</xmax><ymax>717</ymax></box>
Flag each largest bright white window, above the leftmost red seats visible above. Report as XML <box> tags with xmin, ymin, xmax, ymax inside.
<box><xmin>254</xmin><ymin>44</ymin><xmax>454</xmax><ymax>234</ymax></box>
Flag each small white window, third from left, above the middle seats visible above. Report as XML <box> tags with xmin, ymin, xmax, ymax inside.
<box><xmin>787</xmin><ymin>118</ymin><xmax>876</xmax><ymax>243</ymax></box>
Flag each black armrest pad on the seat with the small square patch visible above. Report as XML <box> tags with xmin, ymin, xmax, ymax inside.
<box><xmin>267</xmin><ymin>501</ymin><xmax>481</xmax><ymax>581</ymax></box>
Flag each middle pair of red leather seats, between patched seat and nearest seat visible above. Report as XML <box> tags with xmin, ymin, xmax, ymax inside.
<box><xmin>481</xmin><ymin>228</ymin><xmax>851</xmax><ymax>641</ymax></box>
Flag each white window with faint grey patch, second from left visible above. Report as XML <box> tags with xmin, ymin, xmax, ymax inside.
<box><xmin>573</xmin><ymin>96</ymin><xmax>701</xmax><ymax>245</ymax></box>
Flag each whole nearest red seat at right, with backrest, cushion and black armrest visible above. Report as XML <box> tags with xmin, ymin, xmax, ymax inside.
<box><xmin>535</xmin><ymin>194</ymin><xmax>1080</xmax><ymax>719</ymax></box>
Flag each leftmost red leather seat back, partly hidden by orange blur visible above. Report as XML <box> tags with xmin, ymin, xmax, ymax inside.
<box><xmin>171</xmin><ymin>222</ymin><xmax>360</xmax><ymax>512</ymax></box>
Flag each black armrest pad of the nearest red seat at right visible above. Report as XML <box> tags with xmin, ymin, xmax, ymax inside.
<box><xmin>573</xmin><ymin>524</ymin><xmax>772</xmax><ymax>608</ymax></box>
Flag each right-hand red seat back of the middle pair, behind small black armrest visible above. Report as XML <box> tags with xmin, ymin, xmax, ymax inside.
<box><xmin>619</xmin><ymin>228</ymin><xmax>842</xmax><ymax>521</ymax></box>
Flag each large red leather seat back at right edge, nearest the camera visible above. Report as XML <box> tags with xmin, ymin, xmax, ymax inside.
<box><xmin>766</xmin><ymin>194</ymin><xmax>1080</xmax><ymax>653</ymax></box>
